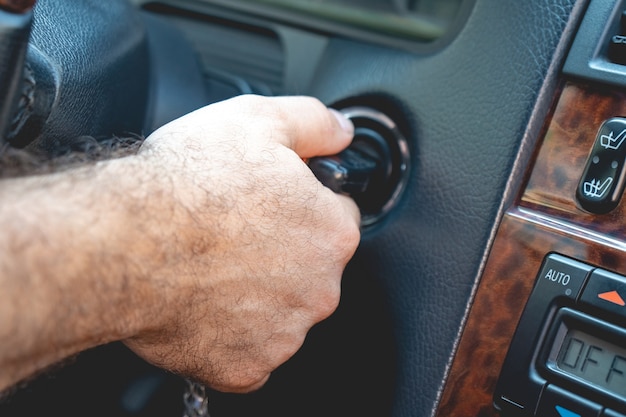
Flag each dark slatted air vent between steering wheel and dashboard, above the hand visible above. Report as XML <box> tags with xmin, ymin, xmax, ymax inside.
<box><xmin>148</xmin><ymin>3</ymin><xmax>285</xmax><ymax>95</ymax></box>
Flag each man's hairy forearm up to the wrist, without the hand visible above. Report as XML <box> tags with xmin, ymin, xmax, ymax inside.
<box><xmin>0</xmin><ymin>158</ymin><xmax>178</xmax><ymax>391</ymax></box>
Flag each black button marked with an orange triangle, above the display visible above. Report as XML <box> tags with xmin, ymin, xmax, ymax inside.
<box><xmin>580</xmin><ymin>269</ymin><xmax>626</xmax><ymax>317</ymax></box>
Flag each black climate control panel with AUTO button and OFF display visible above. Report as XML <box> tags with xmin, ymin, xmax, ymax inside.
<box><xmin>494</xmin><ymin>253</ymin><xmax>626</xmax><ymax>417</ymax></box>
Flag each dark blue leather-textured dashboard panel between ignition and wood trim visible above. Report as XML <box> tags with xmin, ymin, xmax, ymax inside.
<box><xmin>312</xmin><ymin>0</ymin><xmax>575</xmax><ymax>417</ymax></box>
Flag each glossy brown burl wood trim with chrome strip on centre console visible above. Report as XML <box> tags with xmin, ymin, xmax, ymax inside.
<box><xmin>436</xmin><ymin>83</ymin><xmax>626</xmax><ymax>417</ymax></box>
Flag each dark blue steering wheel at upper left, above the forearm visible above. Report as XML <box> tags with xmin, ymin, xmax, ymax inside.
<box><xmin>0</xmin><ymin>0</ymin><xmax>208</xmax><ymax>156</ymax></box>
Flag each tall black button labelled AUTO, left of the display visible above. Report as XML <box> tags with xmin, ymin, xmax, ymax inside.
<box><xmin>494</xmin><ymin>254</ymin><xmax>593</xmax><ymax>415</ymax></box>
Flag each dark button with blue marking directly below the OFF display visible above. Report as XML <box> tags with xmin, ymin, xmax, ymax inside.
<box><xmin>537</xmin><ymin>385</ymin><xmax>602</xmax><ymax>417</ymax></box>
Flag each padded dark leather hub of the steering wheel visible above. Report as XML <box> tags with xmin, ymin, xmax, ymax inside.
<box><xmin>26</xmin><ymin>0</ymin><xmax>150</xmax><ymax>153</ymax></box>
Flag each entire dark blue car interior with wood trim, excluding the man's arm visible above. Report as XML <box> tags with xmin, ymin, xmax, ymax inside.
<box><xmin>0</xmin><ymin>0</ymin><xmax>626</xmax><ymax>417</ymax></box>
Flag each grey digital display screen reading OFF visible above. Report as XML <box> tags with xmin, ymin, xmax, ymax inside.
<box><xmin>556</xmin><ymin>329</ymin><xmax>626</xmax><ymax>397</ymax></box>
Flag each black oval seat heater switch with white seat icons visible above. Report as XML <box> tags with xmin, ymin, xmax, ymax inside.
<box><xmin>576</xmin><ymin>118</ymin><xmax>626</xmax><ymax>214</ymax></box>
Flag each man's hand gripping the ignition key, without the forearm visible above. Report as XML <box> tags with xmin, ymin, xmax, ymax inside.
<box><xmin>126</xmin><ymin>97</ymin><xmax>359</xmax><ymax>391</ymax></box>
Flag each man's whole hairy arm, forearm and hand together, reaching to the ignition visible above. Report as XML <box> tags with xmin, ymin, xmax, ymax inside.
<box><xmin>0</xmin><ymin>96</ymin><xmax>359</xmax><ymax>392</ymax></box>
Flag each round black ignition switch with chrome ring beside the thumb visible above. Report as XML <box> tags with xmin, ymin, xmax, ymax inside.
<box><xmin>309</xmin><ymin>107</ymin><xmax>410</xmax><ymax>226</ymax></box>
